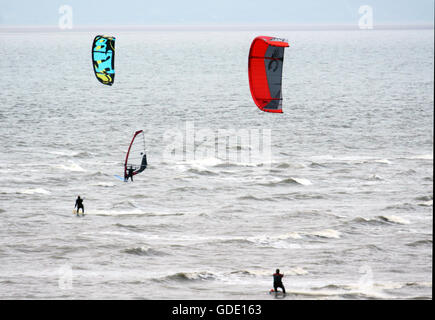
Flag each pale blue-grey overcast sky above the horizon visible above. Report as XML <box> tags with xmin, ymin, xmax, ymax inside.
<box><xmin>0</xmin><ymin>0</ymin><xmax>434</xmax><ymax>26</ymax></box>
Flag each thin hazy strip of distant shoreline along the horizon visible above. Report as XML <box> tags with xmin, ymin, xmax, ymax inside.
<box><xmin>0</xmin><ymin>24</ymin><xmax>434</xmax><ymax>33</ymax></box>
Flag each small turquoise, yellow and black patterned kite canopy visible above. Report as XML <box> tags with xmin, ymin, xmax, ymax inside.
<box><xmin>92</xmin><ymin>35</ymin><xmax>115</xmax><ymax>86</ymax></box>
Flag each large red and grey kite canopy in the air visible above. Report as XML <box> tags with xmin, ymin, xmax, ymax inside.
<box><xmin>248</xmin><ymin>36</ymin><xmax>289</xmax><ymax>113</ymax></box>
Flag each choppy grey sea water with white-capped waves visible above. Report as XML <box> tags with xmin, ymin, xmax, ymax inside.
<box><xmin>0</xmin><ymin>30</ymin><xmax>434</xmax><ymax>299</ymax></box>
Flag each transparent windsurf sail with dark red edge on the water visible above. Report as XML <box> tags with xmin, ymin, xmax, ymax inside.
<box><xmin>124</xmin><ymin>130</ymin><xmax>148</xmax><ymax>177</ymax></box>
